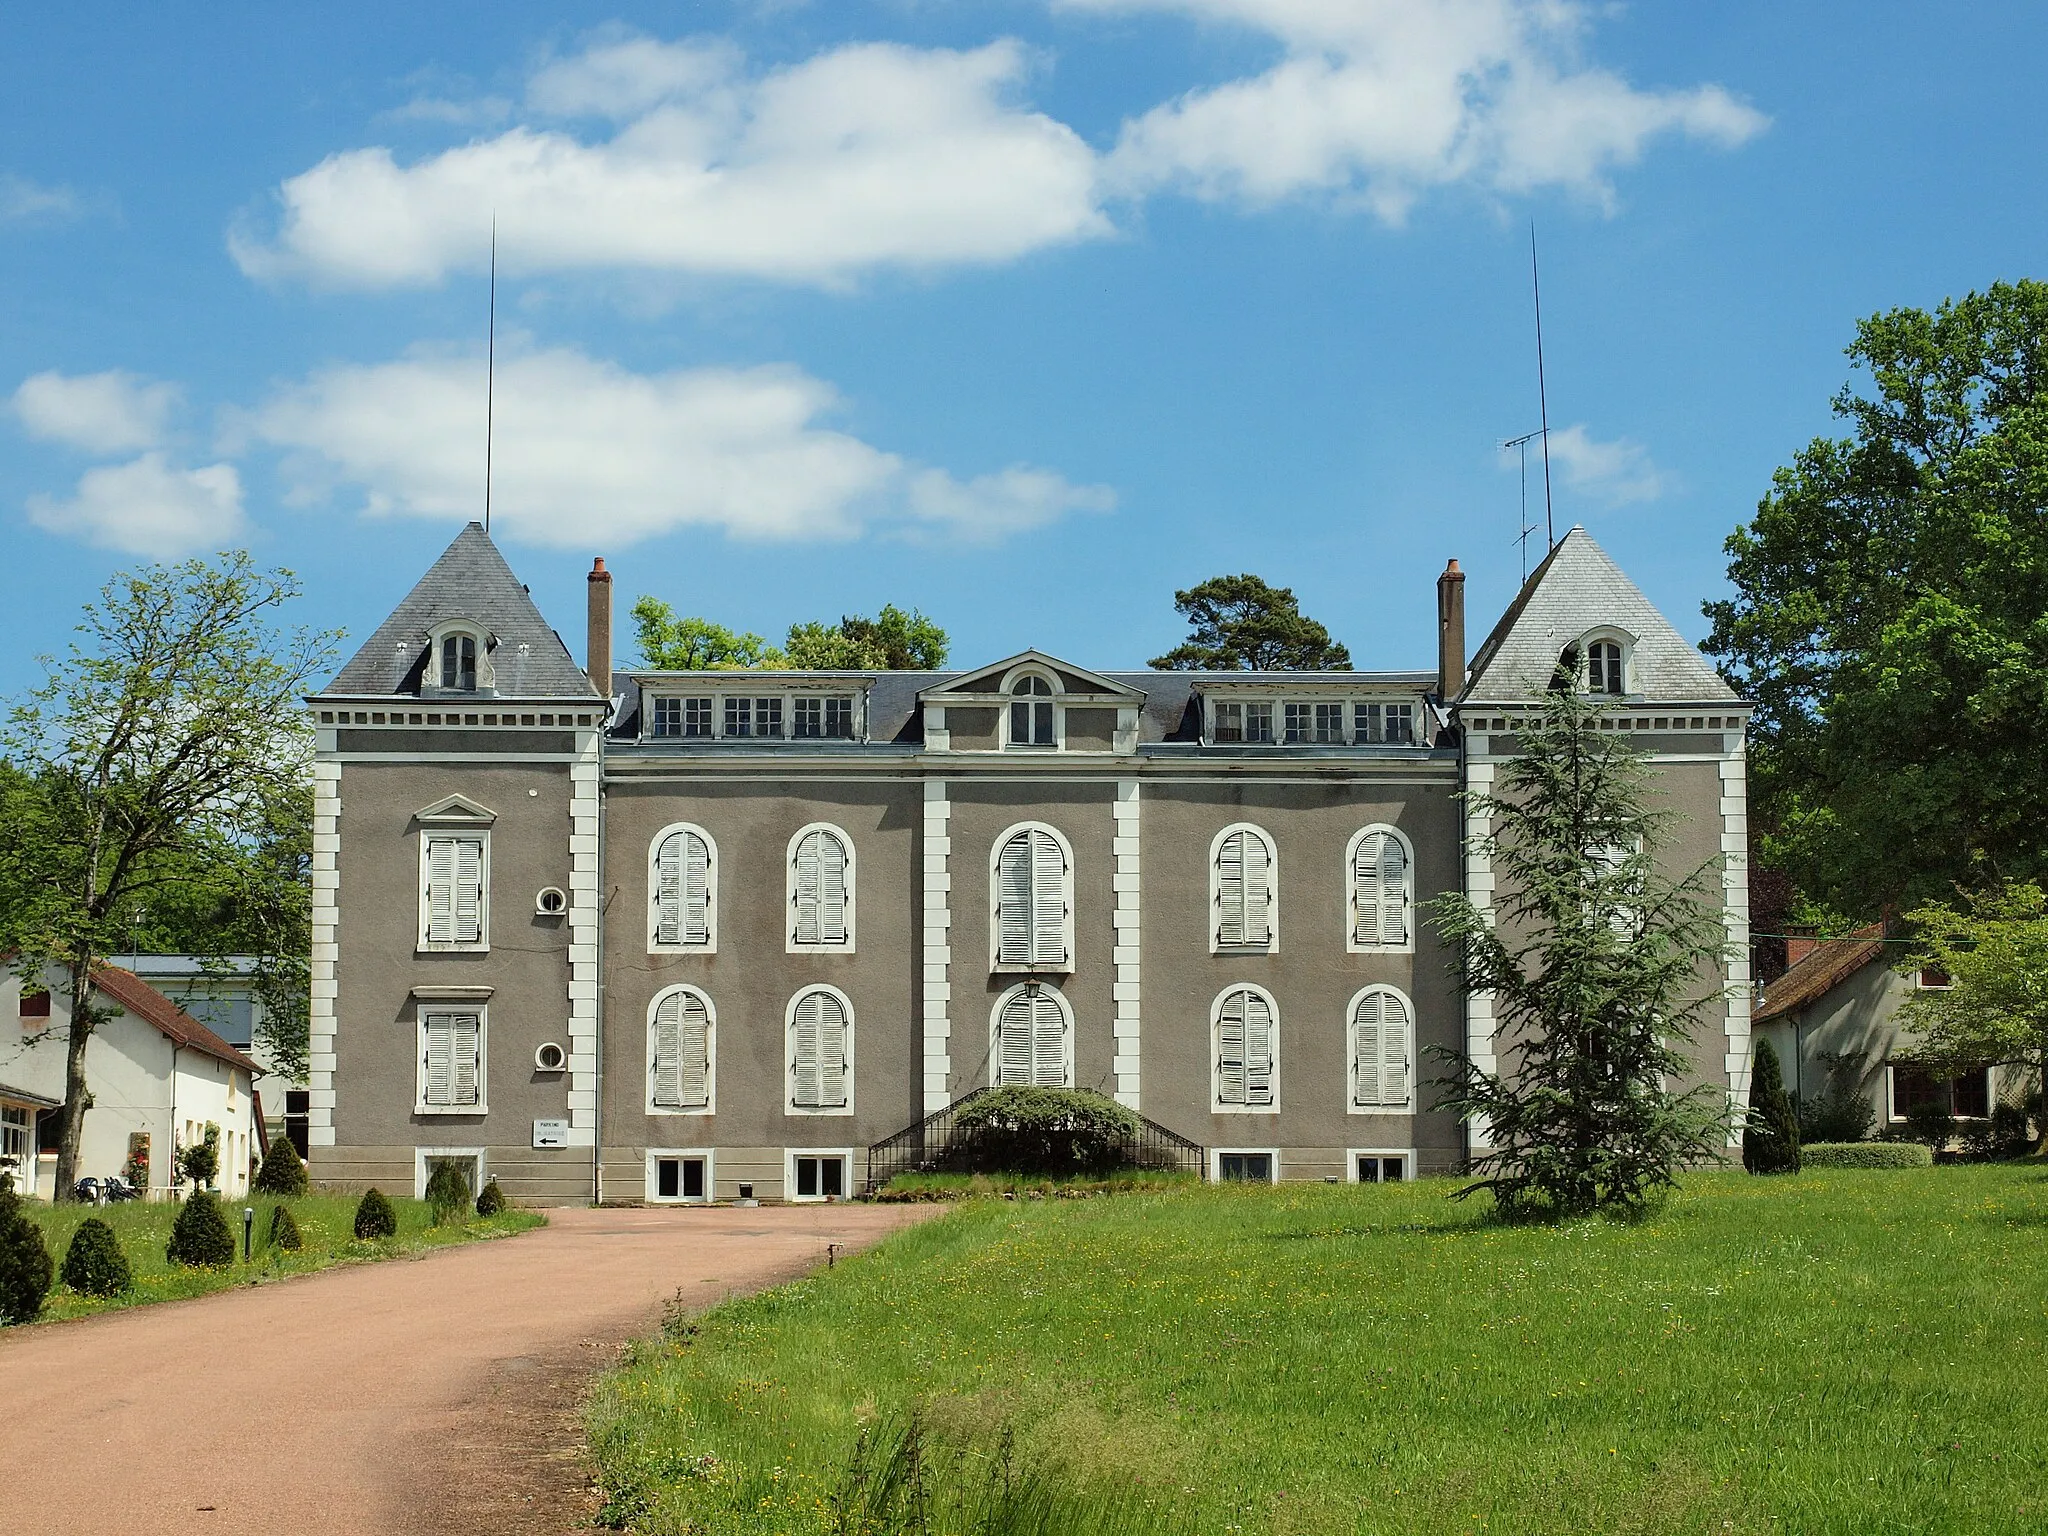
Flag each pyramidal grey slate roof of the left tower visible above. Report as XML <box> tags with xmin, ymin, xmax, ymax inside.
<box><xmin>322</xmin><ymin>522</ymin><xmax>598</xmax><ymax>698</ymax></box>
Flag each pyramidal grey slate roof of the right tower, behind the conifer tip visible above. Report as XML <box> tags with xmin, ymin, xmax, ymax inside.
<box><xmin>1460</xmin><ymin>528</ymin><xmax>1739</xmax><ymax>705</ymax></box>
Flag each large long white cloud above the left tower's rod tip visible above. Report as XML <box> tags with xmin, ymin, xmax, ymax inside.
<box><xmin>229</xmin><ymin>37</ymin><xmax>1108</xmax><ymax>287</ymax></box>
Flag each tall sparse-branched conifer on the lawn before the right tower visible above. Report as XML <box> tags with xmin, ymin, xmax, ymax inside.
<box><xmin>1432</xmin><ymin>679</ymin><xmax>1726</xmax><ymax>1214</ymax></box>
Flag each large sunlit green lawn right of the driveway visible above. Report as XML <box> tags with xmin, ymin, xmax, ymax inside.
<box><xmin>590</xmin><ymin>1163</ymin><xmax>2048</xmax><ymax>1536</ymax></box>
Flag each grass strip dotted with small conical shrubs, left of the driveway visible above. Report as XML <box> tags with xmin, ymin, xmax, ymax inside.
<box><xmin>20</xmin><ymin>1194</ymin><xmax>545</xmax><ymax>1321</ymax></box>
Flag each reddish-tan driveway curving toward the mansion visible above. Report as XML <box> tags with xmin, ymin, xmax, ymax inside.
<box><xmin>0</xmin><ymin>1206</ymin><xmax>928</xmax><ymax>1536</ymax></box>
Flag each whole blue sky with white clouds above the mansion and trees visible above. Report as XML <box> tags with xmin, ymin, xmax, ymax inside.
<box><xmin>0</xmin><ymin>0</ymin><xmax>2048</xmax><ymax>692</ymax></box>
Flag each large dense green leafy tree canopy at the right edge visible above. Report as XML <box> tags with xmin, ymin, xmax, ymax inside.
<box><xmin>1706</xmin><ymin>281</ymin><xmax>2048</xmax><ymax>918</ymax></box>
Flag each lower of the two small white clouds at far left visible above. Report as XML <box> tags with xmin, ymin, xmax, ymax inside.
<box><xmin>29</xmin><ymin>453</ymin><xmax>248</xmax><ymax>559</ymax></box>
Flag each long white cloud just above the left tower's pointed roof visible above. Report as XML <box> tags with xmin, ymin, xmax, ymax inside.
<box><xmin>246</xmin><ymin>348</ymin><xmax>1112</xmax><ymax>547</ymax></box>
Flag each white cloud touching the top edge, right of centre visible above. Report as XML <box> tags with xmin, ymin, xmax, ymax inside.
<box><xmin>1057</xmin><ymin>0</ymin><xmax>1765</xmax><ymax>221</ymax></box>
